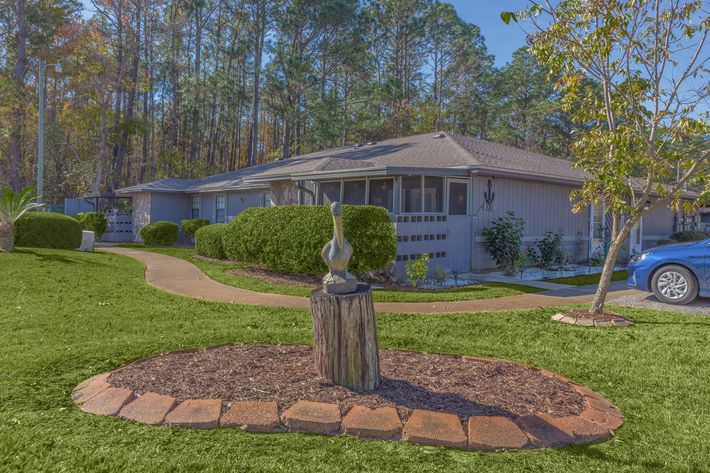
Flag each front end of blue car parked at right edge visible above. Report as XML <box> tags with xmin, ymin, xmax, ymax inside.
<box><xmin>626</xmin><ymin>238</ymin><xmax>710</xmax><ymax>304</ymax></box>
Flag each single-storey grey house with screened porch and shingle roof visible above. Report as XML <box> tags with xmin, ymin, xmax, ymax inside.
<box><xmin>116</xmin><ymin>133</ymin><xmax>696</xmax><ymax>275</ymax></box>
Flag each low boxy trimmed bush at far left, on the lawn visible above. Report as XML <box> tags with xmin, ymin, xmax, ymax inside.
<box><xmin>15</xmin><ymin>212</ymin><xmax>82</xmax><ymax>250</ymax></box>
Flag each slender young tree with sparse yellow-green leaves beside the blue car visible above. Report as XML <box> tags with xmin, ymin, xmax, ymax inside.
<box><xmin>501</xmin><ymin>0</ymin><xmax>710</xmax><ymax>314</ymax></box>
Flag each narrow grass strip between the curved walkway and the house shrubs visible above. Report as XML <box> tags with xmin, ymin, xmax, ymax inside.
<box><xmin>119</xmin><ymin>244</ymin><xmax>543</xmax><ymax>302</ymax></box>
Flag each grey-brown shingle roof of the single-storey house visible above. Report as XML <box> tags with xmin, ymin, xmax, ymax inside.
<box><xmin>117</xmin><ymin>133</ymin><xmax>585</xmax><ymax>194</ymax></box>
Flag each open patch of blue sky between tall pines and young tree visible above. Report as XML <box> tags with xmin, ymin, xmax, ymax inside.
<box><xmin>448</xmin><ymin>0</ymin><xmax>528</xmax><ymax>67</ymax></box>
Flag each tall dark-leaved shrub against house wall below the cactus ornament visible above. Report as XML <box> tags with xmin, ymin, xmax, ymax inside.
<box><xmin>483</xmin><ymin>210</ymin><xmax>525</xmax><ymax>276</ymax></box>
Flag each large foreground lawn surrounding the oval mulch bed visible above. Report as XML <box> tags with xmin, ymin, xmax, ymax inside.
<box><xmin>0</xmin><ymin>245</ymin><xmax>710</xmax><ymax>473</ymax></box>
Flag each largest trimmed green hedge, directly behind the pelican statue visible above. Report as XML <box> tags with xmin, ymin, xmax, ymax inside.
<box><xmin>223</xmin><ymin>205</ymin><xmax>397</xmax><ymax>274</ymax></box>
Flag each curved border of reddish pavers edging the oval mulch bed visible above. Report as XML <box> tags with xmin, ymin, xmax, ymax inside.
<box><xmin>72</xmin><ymin>357</ymin><xmax>624</xmax><ymax>451</ymax></box>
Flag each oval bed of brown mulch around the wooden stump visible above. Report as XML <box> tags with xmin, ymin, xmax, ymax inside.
<box><xmin>109</xmin><ymin>345</ymin><xmax>585</xmax><ymax>420</ymax></box>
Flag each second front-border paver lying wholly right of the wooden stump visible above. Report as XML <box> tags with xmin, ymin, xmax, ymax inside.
<box><xmin>468</xmin><ymin>416</ymin><xmax>530</xmax><ymax>450</ymax></box>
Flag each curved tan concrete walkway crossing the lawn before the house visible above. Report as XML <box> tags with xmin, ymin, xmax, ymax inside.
<box><xmin>100</xmin><ymin>247</ymin><xmax>638</xmax><ymax>313</ymax></box>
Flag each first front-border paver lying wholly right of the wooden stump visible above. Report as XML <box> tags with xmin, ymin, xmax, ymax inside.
<box><xmin>402</xmin><ymin>409</ymin><xmax>467</xmax><ymax>447</ymax></box>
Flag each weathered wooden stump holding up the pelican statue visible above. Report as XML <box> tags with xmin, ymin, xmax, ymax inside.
<box><xmin>311</xmin><ymin>284</ymin><xmax>380</xmax><ymax>391</ymax></box>
